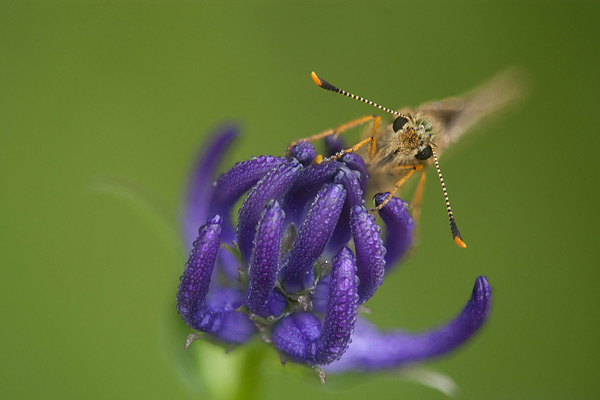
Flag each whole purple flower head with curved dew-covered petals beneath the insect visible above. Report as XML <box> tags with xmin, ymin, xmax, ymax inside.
<box><xmin>177</xmin><ymin>127</ymin><xmax>490</xmax><ymax>372</ymax></box>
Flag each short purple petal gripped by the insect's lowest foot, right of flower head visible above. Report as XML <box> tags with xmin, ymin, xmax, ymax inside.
<box><xmin>374</xmin><ymin>193</ymin><xmax>415</xmax><ymax>270</ymax></box>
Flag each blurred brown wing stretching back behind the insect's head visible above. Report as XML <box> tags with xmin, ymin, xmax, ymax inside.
<box><xmin>419</xmin><ymin>69</ymin><xmax>523</xmax><ymax>153</ymax></box>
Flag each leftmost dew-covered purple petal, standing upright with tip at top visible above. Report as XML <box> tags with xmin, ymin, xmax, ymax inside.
<box><xmin>177</xmin><ymin>215</ymin><xmax>223</xmax><ymax>329</ymax></box>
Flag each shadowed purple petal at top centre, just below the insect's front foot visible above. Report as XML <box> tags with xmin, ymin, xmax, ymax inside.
<box><xmin>283</xmin><ymin>161</ymin><xmax>341</xmax><ymax>224</ymax></box>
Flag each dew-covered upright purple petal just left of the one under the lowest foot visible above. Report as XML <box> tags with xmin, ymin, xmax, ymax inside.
<box><xmin>350</xmin><ymin>206</ymin><xmax>386</xmax><ymax>304</ymax></box>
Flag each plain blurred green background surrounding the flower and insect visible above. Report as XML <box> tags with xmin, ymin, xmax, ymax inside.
<box><xmin>0</xmin><ymin>0</ymin><xmax>600</xmax><ymax>399</ymax></box>
